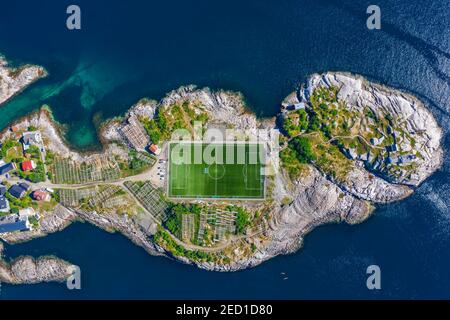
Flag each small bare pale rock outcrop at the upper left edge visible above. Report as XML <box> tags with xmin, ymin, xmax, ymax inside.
<box><xmin>0</xmin><ymin>55</ymin><xmax>47</xmax><ymax>105</ymax></box>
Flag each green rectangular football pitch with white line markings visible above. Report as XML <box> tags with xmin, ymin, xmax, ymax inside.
<box><xmin>168</xmin><ymin>142</ymin><xmax>265</xmax><ymax>200</ymax></box>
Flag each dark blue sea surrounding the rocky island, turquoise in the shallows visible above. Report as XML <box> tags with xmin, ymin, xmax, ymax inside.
<box><xmin>0</xmin><ymin>0</ymin><xmax>450</xmax><ymax>299</ymax></box>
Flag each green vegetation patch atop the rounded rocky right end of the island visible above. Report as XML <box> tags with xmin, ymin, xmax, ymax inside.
<box><xmin>280</xmin><ymin>87</ymin><xmax>370</xmax><ymax>180</ymax></box>
